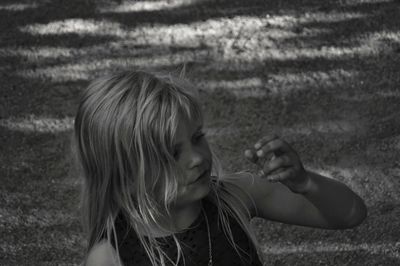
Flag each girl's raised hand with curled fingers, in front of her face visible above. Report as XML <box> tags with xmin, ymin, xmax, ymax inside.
<box><xmin>244</xmin><ymin>135</ymin><xmax>310</xmax><ymax>193</ymax></box>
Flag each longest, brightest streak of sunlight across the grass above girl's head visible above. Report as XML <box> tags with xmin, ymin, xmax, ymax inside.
<box><xmin>16</xmin><ymin>13</ymin><xmax>344</xmax><ymax>43</ymax></box>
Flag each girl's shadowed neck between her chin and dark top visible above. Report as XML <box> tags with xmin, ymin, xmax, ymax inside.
<box><xmin>140</xmin><ymin>200</ymin><xmax>203</xmax><ymax>238</ymax></box>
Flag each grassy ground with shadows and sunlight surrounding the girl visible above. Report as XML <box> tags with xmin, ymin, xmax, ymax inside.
<box><xmin>0</xmin><ymin>0</ymin><xmax>400</xmax><ymax>265</ymax></box>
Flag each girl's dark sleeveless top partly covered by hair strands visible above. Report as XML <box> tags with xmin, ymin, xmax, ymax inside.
<box><xmin>115</xmin><ymin>199</ymin><xmax>262</xmax><ymax>266</ymax></box>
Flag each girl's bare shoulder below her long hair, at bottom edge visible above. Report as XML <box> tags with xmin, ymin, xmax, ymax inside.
<box><xmin>85</xmin><ymin>240</ymin><xmax>118</xmax><ymax>266</ymax></box>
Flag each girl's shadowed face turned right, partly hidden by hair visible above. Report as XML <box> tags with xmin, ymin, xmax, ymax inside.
<box><xmin>174</xmin><ymin>116</ymin><xmax>212</xmax><ymax>206</ymax></box>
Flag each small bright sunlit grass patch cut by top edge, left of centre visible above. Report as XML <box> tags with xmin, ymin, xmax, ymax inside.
<box><xmin>99</xmin><ymin>0</ymin><xmax>193</xmax><ymax>13</ymax></box>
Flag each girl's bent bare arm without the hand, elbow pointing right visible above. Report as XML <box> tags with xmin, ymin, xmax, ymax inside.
<box><xmin>240</xmin><ymin>172</ymin><xmax>367</xmax><ymax>229</ymax></box>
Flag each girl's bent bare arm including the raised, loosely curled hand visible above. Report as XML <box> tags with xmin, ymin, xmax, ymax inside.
<box><xmin>233</xmin><ymin>136</ymin><xmax>367</xmax><ymax>229</ymax></box>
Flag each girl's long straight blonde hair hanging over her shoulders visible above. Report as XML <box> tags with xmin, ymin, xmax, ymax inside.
<box><xmin>73</xmin><ymin>70</ymin><xmax>259</xmax><ymax>265</ymax></box>
